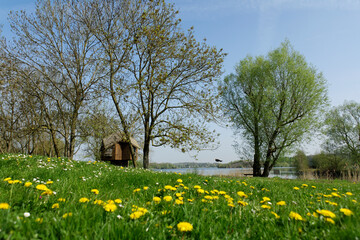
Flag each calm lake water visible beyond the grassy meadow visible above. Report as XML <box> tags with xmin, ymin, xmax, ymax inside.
<box><xmin>153</xmin><ymin>167</ymin><xmax>297</xmax><ymax>179</ymax></box>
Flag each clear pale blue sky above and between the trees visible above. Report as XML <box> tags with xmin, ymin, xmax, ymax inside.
<box><xmin>0</xmin><ymin>0</ymin><xmax>360</xmax><ymax>162</ymax></box>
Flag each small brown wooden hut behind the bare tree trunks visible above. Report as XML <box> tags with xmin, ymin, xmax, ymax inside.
<box><xmin>100</xmin><ymin>133</ymin><xmax>140</xmax><ymax>167</ymax></box>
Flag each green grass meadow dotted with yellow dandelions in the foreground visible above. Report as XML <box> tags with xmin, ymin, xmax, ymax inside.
<box><xmin>0</xmin><ymin>155</ymin><xmax>360</xmax><ymax>239</ymax></box>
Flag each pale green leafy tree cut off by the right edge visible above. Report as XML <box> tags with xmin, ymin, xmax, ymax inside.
<box><xmin>324</xmin><ymin>102</ymin><xmax>360</xmax><ymax>164</ymax></box>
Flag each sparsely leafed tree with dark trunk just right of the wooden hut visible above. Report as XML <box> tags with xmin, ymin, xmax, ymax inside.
<box><xmin>122</xmin><ymin>0</ymin><xmax>225</xmax><ymax>168</ymax></box>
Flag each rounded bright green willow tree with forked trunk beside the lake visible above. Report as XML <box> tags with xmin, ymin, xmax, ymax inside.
<box><xmin>221</xmin><ymin>41</ymin><xmax>327</xmax><ymax>177</ymax></box>
